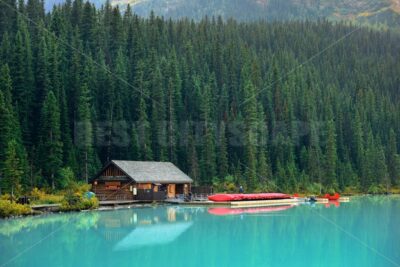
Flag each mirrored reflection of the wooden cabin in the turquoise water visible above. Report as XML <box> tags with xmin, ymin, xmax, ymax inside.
<box><xmin>94</xmin><ymin>207</ymin><xmax>198</xmax><ymax>249</ymax></box>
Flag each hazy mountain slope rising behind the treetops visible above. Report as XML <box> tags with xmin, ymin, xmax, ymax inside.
<box><xmin>112</xmin><ymin>0</ymin><xmax>400</xmax><ymax>27</ymax></box>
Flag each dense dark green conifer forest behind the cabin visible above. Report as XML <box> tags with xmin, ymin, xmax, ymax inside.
<box><xmin>0</xmin><ymin>0</ymin><xmax>400</xmax><ymax>192</ymax></box>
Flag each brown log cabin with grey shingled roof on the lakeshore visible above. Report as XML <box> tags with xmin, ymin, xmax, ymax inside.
<box><xmin>91</xmin><ymin>160</ymin><xmax>193</xmax><ymax>200</ymax></box>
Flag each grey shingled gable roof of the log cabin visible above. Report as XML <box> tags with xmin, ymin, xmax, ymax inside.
<box><xmin>96</xmin><ymin>160</ymin><xmax>193</xmax><ymax>184</ymax></box>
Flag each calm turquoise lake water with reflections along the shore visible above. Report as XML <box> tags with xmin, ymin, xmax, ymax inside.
<box><xmin>0</xmin><ymin>196</ymin><xmax>400</xmax><ymax>267</ymax></box>
